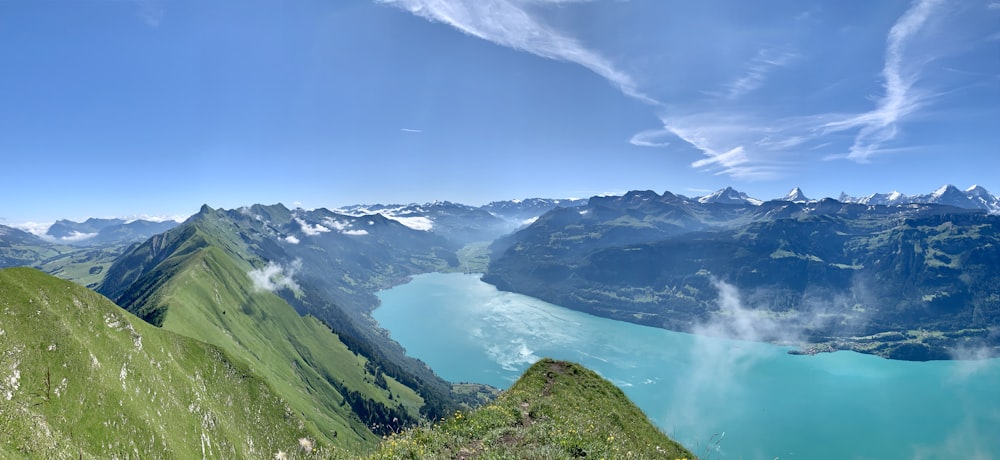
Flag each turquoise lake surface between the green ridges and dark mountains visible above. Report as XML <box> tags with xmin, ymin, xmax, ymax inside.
<box><xmin>373</xmin><ymin>273</ymin><xmax>1000</xmax><ymax>460</ymax></box>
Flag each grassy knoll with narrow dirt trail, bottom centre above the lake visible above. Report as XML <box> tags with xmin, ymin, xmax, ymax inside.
<box><xmin>371</xmin><ymin>359</ymin><xmax>694</xmax><ymax>460</ymax></box>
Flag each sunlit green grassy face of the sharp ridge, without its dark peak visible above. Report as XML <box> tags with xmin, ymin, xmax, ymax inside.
<box><xmin>153</xmin><ymin>247</ymin><xmax>422</xmax><ymax>447</ymax></box>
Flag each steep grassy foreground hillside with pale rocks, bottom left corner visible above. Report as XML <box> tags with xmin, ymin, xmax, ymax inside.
<box><xmin>0</xmin><ymin>268</ymin><xmax>315</xmax><ymax>458</ymax></box>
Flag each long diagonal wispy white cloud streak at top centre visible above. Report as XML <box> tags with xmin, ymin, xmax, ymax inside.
<box><xmin>376</xmin><ymin>0</ymin><xmax>659</xmax><ymax>105</ymax></box>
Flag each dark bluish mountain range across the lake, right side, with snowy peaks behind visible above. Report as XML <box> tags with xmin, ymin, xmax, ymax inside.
<box><xmin>483</xmin><ymin>187</ymin><xmax>1000</xmax><ymax>359</ymax></box>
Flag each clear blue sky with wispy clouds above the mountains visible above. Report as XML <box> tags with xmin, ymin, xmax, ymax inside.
<box><xmin>0</xmin><ymin>0</ymin><xmax>1000</xmax><ymax>225</ymax></box>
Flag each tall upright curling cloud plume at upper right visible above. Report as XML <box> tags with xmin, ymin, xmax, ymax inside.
<box><xmin>825</xmin><ymin>0</ymin><xmax>942</xmax><ymax>163</ymax></box>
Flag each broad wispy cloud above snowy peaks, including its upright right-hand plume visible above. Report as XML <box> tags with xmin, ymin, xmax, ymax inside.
<box><xmin>652</xmin><ymin>0</ymin><xmax>941</xmax><ymax>180</ymax></box>
